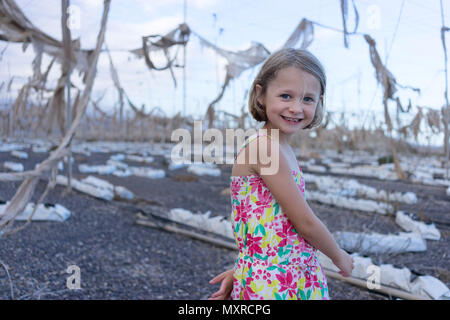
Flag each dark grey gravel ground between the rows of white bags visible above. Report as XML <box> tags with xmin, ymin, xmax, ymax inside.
<box><xmin>0</xmin><ymin>145</ymin><xmax>450</xmax><ymax>300</ymax></box>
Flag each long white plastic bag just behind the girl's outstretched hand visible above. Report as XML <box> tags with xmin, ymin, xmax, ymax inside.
<box><xmin>333</xmin><ymin>231</ymin><xmax>427</xmax><ymax>254</ymax></box>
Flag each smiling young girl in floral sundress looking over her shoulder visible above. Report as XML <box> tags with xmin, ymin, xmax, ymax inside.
<box><xmin>210</xmin><ymin>48</ymin><xmax>353</xmax><ymax>300</ymax></box>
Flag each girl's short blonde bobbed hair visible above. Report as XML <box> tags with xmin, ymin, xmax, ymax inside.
<box><xmin>248</xmin><ymin>48</ymin><xmax>327</xmax><ymax>129</ymax></box>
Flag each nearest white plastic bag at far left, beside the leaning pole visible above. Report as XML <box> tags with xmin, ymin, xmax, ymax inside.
<box><xmin>0</xmin><ymin>201</ymin><xmax>70</xmax><ymax>222</ymax></box>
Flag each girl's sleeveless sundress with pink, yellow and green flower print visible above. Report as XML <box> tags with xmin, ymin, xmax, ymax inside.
<box><xmin>230</xmin><ymin>133</ymin><xmax>330</xmax><ymax>300</ymax></box>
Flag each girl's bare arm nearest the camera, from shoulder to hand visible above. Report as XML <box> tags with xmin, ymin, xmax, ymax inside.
<box><xmin>254</xmin><ymin>137</ymin><xmax>353</xmax><ymax>276</ymax></box>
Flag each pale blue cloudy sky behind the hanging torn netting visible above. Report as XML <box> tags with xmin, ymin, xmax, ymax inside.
<box><xmin>0</xmin><ymin>0</ymin><xmax>450</xmax><ymax>146</ymax></box>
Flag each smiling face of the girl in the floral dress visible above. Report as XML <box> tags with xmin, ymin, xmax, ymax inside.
<box><xmin>255</xmin><ymin>66</ymin><xmax>323</xmax><ymax>136</ymax></box>
